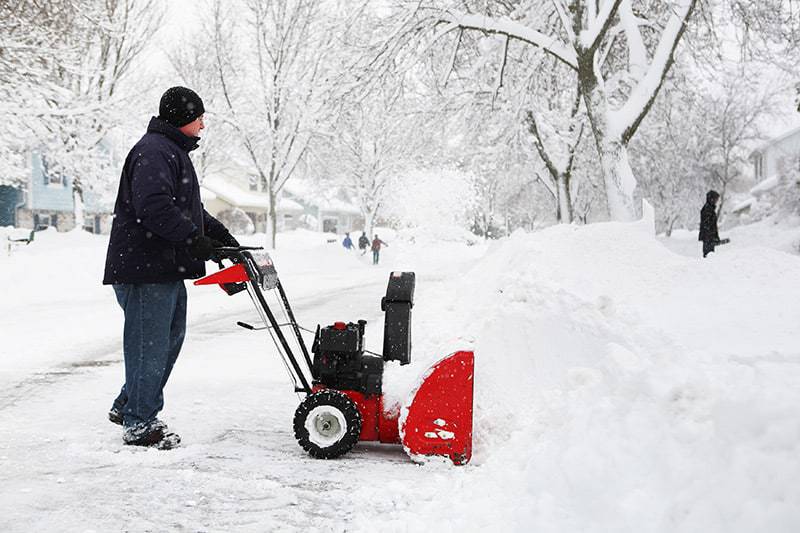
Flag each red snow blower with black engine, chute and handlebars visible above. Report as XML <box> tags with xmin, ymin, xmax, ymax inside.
<box><xmin>194</xmin><ymin>246</ymin><xmax>474</xmax><ymax>465</ymax></box>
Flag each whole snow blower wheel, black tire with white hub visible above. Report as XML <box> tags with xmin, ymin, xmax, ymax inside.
<box><xmin>294</xmin><ymin>389</ymin><xmax>361</xmax><ymax>459</ymax></box>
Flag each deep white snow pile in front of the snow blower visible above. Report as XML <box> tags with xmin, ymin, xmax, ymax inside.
<box><xmin>376</xmin><ymin>219</ymin><xmax>800</xmax><ymax>531</ymax></box>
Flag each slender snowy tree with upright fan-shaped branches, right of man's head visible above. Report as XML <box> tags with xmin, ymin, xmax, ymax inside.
<box><xmin>202</xmin><ymin>0</ymin><xmax>358</xmax><ymax>247</ymax></box>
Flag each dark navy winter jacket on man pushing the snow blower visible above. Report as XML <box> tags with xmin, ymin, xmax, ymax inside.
<box><xmin>103</xmin><ymin>117</ymin><xmax>235</xmax><ymax>284</ymax></box>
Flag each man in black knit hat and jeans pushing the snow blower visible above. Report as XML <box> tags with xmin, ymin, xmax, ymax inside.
<box><xmin>103</xmin><ymin>87</ymin><xmax>239</xmax><ymax>449</ymax></box>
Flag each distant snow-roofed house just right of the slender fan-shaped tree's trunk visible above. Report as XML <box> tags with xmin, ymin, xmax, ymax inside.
<box><xmin>284</xmin><ymin>180</ymin><xmax>364</xmax><ymax>234</ymax></box>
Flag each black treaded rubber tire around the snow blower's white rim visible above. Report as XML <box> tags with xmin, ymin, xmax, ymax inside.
<box><xmin>294</xmin><ymin>389</ymin><xmax>361</xmax><ymax>459</ymax></box>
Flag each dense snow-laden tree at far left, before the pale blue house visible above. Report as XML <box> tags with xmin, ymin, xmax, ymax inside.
<box><xmin>0</xmin><ymin>0</ymin><xmax>161</xmax><ymax>227</ymax></box>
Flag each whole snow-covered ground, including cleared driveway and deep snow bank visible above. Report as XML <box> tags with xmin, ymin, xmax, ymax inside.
<box><xmin>0</xmin><ymin>220</ymin><xmax>800</xmax><ymax>532</ymax></box>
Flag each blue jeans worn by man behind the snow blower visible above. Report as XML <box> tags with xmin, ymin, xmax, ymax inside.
<box><xmin>113</xmin><ymin>281</ymin><xmax>186</xmax><ymax>427</ymax></box>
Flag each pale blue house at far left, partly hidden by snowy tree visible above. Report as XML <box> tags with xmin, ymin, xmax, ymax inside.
<box><xmin>0</xmin><ymin>151</ymin><xmax>113</xmax><ymax>233</ymax></box>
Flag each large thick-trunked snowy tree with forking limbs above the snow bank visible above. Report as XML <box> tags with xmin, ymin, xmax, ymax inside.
<box><xmin>382</xmin><ymin>0</ymin><xmax>697</xmax><ymax>220</ymax></box>
